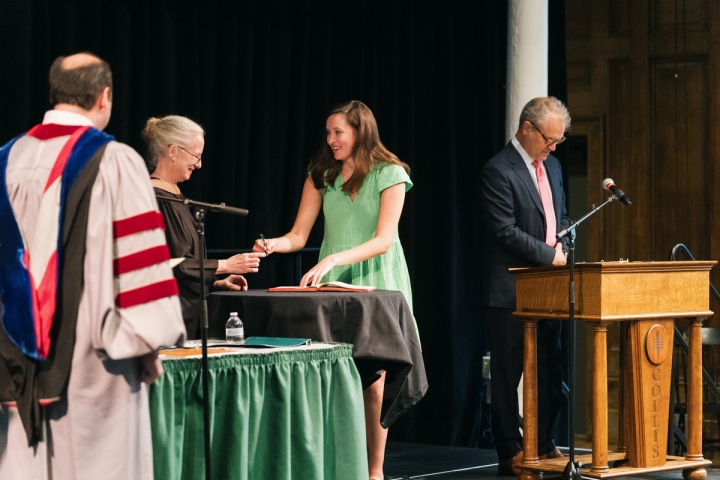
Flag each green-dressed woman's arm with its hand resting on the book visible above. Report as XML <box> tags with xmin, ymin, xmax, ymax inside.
<box><xmin>300</xmin><ymin>183</ymin><xmax>405</xmax><ymax>287</ymax></box>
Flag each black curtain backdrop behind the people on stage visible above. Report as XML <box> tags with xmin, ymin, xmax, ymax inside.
<box><xmin>0</xmin><ymin>0</ymin><xmax>564</xmax><ymax>445</ymax></box>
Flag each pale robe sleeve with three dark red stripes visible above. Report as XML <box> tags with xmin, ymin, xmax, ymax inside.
<box><xmin>86</xmin><ymin>142</ymin><xmax>185</xmax><ymax>359</ymax></box>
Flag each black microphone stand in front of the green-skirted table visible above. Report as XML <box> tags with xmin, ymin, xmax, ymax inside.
<box><xmin>155</xmin><ymin>195</ymin><xmax>248</xmax><ymax>480</ymax></box>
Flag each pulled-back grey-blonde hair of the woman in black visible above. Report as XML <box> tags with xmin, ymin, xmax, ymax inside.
<box><xmin>141</xmin><ymin>115</ymin><xmax>205</xmax><ymax>172</ymax></box>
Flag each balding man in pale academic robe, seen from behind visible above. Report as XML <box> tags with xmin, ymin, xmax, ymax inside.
<box><xmin>0</xmin><ymin>53</ymin><xmax>185</xmax><ymax>480</ymax></box>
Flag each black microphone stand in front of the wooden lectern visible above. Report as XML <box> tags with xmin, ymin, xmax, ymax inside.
<box><xmin>555</xmin><ymin>195</ymin><xmax>620</xmax><ymax>480</ymax></box>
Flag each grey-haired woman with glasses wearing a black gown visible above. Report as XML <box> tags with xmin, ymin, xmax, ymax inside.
<box><xmin>142</xmin><ymin>115</ymin><xmax>265</xmax><ymax>339</ymax></box>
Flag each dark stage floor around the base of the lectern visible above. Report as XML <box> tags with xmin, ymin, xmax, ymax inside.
<box><xmin>385</xmin><ymin>442</ymin><xmax>720</xmax><ymax>480</ymax></box>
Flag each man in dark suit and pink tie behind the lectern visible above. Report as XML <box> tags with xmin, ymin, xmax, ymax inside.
<box><xmin>480</xmin><ymin>97</ymin><xmax>570</xmax><ymax>474</ymax></box>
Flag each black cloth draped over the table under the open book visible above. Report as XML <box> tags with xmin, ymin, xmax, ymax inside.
<box><xmin>208</xmin><ymin>290</ymin><xmax>427</xmax><ymax>427</ymax></box>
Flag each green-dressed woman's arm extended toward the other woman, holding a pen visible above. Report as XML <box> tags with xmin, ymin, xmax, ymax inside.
<box><xmin>253</xmin><ymin>177</ymin><xmax>322</xmax><ymax>255</ymax></box>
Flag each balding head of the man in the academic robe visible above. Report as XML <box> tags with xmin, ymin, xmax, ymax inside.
<box><xmin>50</xmin><ymin>53</ymin><xmax>113</xmax><ymax>130</ymax></box>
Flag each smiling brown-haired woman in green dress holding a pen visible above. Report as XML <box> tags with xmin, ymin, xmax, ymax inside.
<box><xmin>253</xmin><ymin>100</ymin><xmax>412</xmax><ymax>479</ymax></box>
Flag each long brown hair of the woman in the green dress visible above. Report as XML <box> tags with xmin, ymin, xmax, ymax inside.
<box><xmin>308</xmin><ymin>100</ymin><xmax>410</xmax><ymax>193</ymax></box>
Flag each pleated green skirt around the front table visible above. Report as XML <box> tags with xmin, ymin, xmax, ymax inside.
<box><xmin>150</xmin><ymin>344</ymin><xmax>368</xmax><ymax>480</ymax></box>
